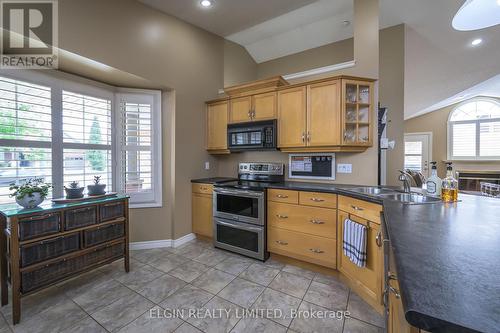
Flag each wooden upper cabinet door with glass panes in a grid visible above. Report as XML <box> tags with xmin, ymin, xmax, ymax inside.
<box><xmin>342</xmin><ymin>79</ymin><xmax>373</xmax><ymax>146</ymax></box>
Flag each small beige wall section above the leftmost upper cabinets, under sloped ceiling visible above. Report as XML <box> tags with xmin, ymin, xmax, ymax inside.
<box><xmin>224</xmin><ymin>40</ymin><xmax>257</xmax><ymax>88</ymax></box>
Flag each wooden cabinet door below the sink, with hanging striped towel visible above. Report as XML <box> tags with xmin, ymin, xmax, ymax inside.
<box><xmin>337</xmin><ymin>210</ymin><xmax>384</xmax><ymax>305</ymax></box>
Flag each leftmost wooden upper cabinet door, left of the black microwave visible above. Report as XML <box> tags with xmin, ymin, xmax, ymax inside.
<box><xmin>207</xmin><ymin>102</ymin><xmax>228</xmax><ymax>150</ymax></box>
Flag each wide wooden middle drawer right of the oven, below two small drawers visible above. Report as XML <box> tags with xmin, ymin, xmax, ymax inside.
<box><xmin>267</xmin><ymin>202</ymin><xmax>337</xmax><ymax>239</ymax></box>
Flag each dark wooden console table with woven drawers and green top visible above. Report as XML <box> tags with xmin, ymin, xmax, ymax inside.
<box><xmin>0</xmin><ymin>195</ymin><xmax>129</xmax><ymax>324</ymax></box>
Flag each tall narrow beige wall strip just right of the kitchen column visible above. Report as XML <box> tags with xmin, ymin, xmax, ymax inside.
<box><xmin>379</xmin><ymin>25</ymin><xmax>405</xmax><ymax>185</ymax></box>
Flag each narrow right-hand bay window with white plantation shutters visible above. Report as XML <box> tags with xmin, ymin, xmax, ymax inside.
<box><xmin>117</xmin><ymin>90</ymin><xmax>162</xmax><ymax>207</ymax></box>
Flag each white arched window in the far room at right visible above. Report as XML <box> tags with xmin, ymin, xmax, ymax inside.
<box><xmin>448</xmin><ymin>99</ymin><xmax>500</xmax><ymax>160</ymax></box>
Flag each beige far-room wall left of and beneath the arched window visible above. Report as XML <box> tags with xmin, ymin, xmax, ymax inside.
<box><xmin>405</xmin><ymin>99</ymin><xmax>500</xmax><ymax>178</ymax></box>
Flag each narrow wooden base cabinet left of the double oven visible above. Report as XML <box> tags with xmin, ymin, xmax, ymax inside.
<box><xmin>191</xmin><ymin>184</ymin><xmax>213</xmax><ymax>238</ymax></box>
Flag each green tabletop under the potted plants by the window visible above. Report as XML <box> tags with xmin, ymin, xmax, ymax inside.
<box><xmin>0</xmin><ymin>194</ymin><xmax>129</xmax><ymax>217</ymax></box>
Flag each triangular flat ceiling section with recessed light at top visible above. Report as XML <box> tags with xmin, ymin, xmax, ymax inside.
<box><xmin>139</xmin><ymin>0</ymin><xmax>316</xmax><ymax>37</ymax></box>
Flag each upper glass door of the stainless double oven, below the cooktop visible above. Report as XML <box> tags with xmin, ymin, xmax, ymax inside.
<box><xmin>214</xmin><ymin>189</ymin><xmax>264</xmax><ymax>224</ymax></box>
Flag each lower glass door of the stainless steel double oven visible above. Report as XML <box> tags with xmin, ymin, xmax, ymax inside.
<box><xmin>214</xmin><ymin>219</ymin><xmax>264</xmax><ymax>260</ymax></box>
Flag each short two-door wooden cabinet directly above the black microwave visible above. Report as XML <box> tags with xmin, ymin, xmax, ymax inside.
<box><xmin>229</xmin><ymin>92</ymin><xmax>277</xmax><ymax>123</ymax></box>
